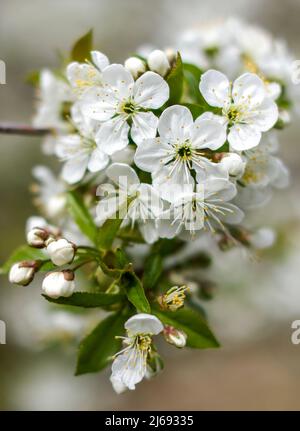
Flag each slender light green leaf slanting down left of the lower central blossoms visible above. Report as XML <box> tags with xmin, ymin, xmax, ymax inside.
<box><xmin>67</xmin><ymin>191</ymin><xmax>97</xmax><ymax>242</ymax></box>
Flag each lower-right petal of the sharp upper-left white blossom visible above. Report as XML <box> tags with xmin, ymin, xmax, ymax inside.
<box><xmin>131</xmin><ymin>112</ymin><xmax>158</xmax><ymax>145</ymax></box>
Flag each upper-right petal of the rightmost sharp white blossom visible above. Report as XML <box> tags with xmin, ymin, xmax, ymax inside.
<box><xmin>232</xmin><ymin>73</ymin><xmax>266</xmax><ymax>107</ymax></box>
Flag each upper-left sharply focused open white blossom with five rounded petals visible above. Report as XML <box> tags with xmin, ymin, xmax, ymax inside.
<box><xmin>82</xmin><ymin>64</ymin><xmax>169</xmax><ymax>155</ymax></box>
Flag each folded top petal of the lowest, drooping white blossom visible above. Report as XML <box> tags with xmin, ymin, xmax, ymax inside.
<box><xmin>125</xmin><ymin>313</ymin><xmax>164</xmax><ymax>335</ymax></box>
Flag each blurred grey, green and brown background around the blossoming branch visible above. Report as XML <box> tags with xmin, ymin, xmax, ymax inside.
<box><xmin>0</xmin><ymin>0</ymin><xmax>300</xmax><ymax>410</ymax></box>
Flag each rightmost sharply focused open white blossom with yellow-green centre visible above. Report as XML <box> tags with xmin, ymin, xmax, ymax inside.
<box><xmin>199</xmin><ymin>70</ymin><xmax>278</xmax><ymax>151</ymax></box>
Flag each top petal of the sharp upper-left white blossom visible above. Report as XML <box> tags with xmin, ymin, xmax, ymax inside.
<box><xmin>102</xmin><ymin>64</ymin><xmax>134</xmax><ymax>100</ymax></box>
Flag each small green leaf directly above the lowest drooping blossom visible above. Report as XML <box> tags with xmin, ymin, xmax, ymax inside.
<box><xmin>120</xmin><ymin>271</ymin><xmax>151</xmax><ymax>313</ymax></box>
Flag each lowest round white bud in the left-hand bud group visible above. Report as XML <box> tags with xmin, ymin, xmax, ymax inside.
<box><xmin>42</xmin><ymin>270</ymin><xmax>75</xmax><ymax>299</ymax></box>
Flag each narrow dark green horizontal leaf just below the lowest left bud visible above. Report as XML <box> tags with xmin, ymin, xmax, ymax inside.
<box><xmin>43</xmin><ymin>292</ymin><xmax>124</xmax><ymax>308</ymax></box>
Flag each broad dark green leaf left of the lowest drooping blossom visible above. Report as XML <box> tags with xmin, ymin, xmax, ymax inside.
<box><xmin>75</xmin><ymin>312</ymin><xmax>128</xmax><ymax>376</ymax></box>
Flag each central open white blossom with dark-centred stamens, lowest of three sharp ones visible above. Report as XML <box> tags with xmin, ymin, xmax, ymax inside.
<box><xmin>134</xmin><ymin>105</ymin><xmax>226</xmax><ymax>201</ymax></box>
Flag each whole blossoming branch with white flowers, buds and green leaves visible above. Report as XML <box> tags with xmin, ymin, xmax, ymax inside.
<box><xmin>0</xmin><ymin>20</ymin><xmax>299</xmax><ymax>392</ymax></box>
